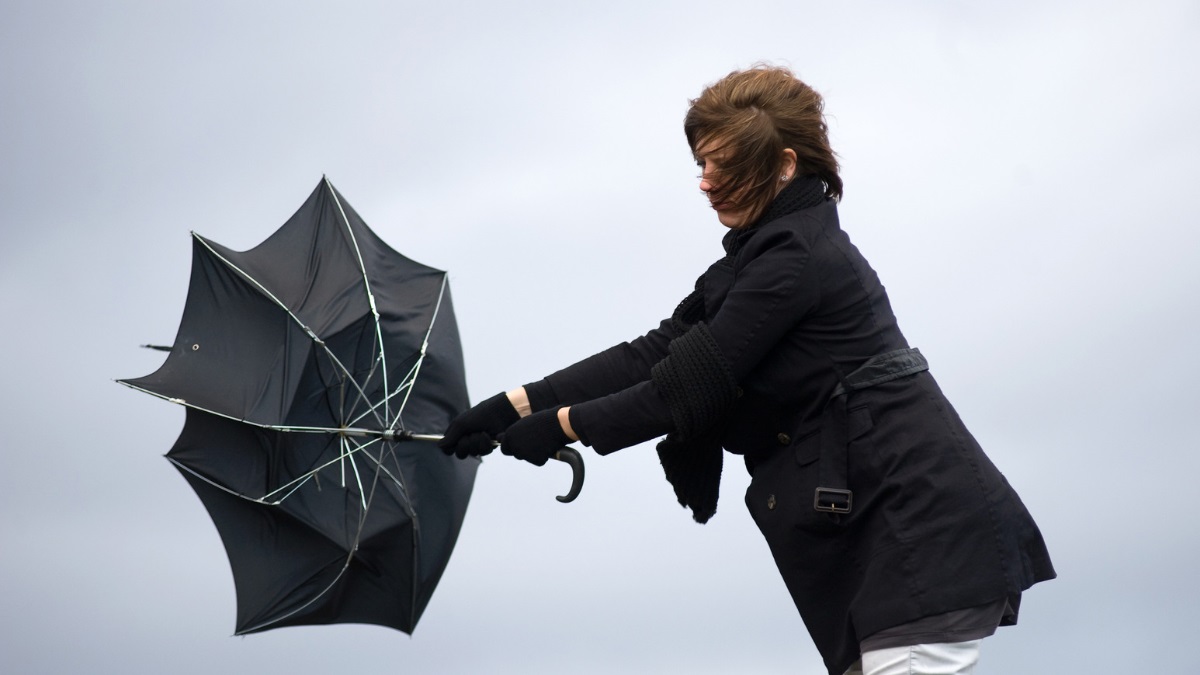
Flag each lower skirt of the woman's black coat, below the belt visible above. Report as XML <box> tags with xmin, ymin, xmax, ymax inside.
<box><xmin>746</xmin><ymin>371</ymin><xmax>1055</xmax><ymax>674</ymax></box>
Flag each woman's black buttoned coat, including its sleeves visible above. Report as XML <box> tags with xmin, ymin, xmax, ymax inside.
<box><xmin>529</xmin><ymin>187</ymin><xmax>1055</xmax><ymax>675</ymax></box>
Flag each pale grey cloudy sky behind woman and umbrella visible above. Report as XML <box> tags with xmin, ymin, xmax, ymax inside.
<box><xmin>0</xmin><ymin>0</ymin><xmax>1200</xmax><ymax>675</ymax></box>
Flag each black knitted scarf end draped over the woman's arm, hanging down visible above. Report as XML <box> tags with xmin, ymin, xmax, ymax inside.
<box><xmin>650</xmin><ymin>319</ymin><xmax>738</xmax><ymax>524</ymax></box>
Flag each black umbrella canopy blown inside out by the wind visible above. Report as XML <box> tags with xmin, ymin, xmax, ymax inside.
<box><xmin>121</xmin><ymin>179</ymin><xmax>479</xmax><ymax>634</ymax></box>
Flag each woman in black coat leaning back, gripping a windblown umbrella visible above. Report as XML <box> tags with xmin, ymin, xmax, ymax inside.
<box><xmin>442</xmin><ymin>66</ymin><xmax>1055</xmax><ymax>675</ymax></box>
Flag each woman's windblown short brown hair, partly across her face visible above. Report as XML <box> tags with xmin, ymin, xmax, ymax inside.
<box><xmin>683</xmin><ymin>65</ymin><xmax>841</xmax><ymax>221</ymax></box>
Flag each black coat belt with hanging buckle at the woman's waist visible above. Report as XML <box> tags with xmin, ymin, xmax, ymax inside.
<box><xmin>812</xmin><ymin>347</ymin><xmax>929</xmax><ymax>514</ymax></box>
